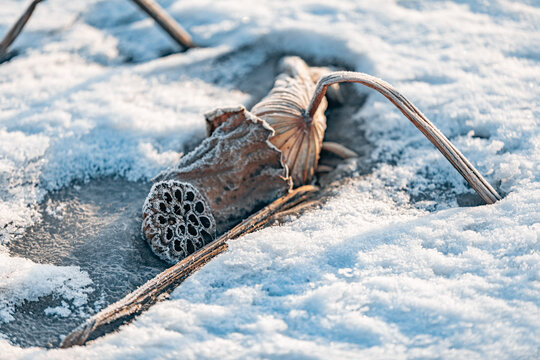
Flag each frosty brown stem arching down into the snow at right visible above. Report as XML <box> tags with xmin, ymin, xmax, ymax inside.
<box><xmin>307</xmin><ymin>71</ymin><xmax>501</xmax><ymax>204</ymax></box>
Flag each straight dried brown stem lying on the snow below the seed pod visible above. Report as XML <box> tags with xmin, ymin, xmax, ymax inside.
<box><xmin>60</xmin><ymin>185</ymin><xmax>318</xmax><ymax>348</ymax></box>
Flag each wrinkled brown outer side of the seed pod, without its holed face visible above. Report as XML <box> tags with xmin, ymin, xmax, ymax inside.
<box><xmin>153</xmin><ymin>106</ymin><xmax>292</xmax><ymax>234</ymax></box>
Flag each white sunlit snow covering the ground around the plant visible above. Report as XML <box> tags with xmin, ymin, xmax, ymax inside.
<box><xmin>0</xmin><ymin>0</ymin><xmax>540</xmax><ymax>359</ymax></box>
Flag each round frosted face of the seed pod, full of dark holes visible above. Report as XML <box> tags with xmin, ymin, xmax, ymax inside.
<box><xmin>142</xmin><ymin>180</ymin><xmax>216</xmax><ymax>263</ymax></box>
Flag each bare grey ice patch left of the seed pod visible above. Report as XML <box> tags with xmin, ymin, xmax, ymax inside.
<box><xmin>0</xmin><ymin>178</ymin><xmax>167</xmax><ymax>347</ymax></box>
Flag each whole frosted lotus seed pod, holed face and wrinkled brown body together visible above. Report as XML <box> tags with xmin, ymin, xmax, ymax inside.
<box><xmin>143</xmin><ymin>106</ymin><xmax>292</xmax><ymax>262</ymax></box>
